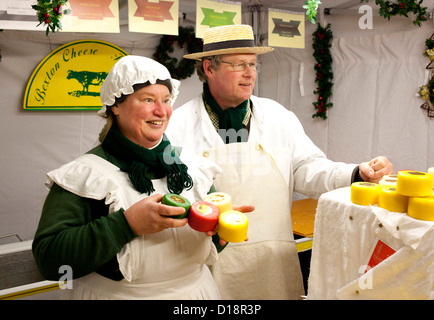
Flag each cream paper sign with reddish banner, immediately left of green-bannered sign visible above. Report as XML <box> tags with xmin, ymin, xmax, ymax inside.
<box><xmin>128</xmin><ymin>0</ymin><xmax>179</xmax><ymax>35</ymax></box>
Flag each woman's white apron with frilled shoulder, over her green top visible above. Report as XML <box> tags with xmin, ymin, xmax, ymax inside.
<box><xmin>48</xmin><ymin>155</ymin><xmax>220</xmax><ymax>300</ymax></box>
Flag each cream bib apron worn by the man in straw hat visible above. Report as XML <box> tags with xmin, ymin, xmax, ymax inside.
<box><xmin>203</xmin><ymin>142</ymin><xmax>304</xmax><ymax>300</ymax></box>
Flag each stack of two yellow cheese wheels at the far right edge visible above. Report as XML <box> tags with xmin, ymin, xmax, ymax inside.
<box><xmin>396</xmin><ymin>170</ymin><xmax>434</xmax><ymax>221</ymax></box>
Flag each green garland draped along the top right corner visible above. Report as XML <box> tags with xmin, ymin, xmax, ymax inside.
<box><xmin>361</xmin><ymin>0</ymin><xmax>427</xmax><ymax>27</ymax></box>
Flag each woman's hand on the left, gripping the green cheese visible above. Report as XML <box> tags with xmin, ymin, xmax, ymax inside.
<box><xmin>124</xmin><ymin>194</ymin><xmax>188</xmax><ymax>236</ymax></box>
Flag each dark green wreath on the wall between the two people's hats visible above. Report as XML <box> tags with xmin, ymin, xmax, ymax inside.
<box><xmin>153</xmin><ymin>27</ymin><xmax>203</xmax><ymax>80</ymax></box>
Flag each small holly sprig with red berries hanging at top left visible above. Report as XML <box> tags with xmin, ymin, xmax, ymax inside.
<box><xmin>32</xmin><ymin>0</ymin><xmax>71</xmax><ymax>36</ymax></box>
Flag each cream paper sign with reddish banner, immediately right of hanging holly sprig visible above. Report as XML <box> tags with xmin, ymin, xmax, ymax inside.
<box><xmin>59</xmin><ymin>0</ymin><xmax>120</xmax><ymax>33</ymax></box>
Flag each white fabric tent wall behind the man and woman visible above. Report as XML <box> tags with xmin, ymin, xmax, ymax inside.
<box><xmin>0</xmin><ymin>0</ymin><xmax>434</xmax><ymax>244</ymax></box>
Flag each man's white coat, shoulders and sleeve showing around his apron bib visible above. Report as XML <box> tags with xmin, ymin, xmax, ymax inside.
<box><xmin>166</xmin><ymin>95</ymin><xmax>357</xmax><ymax>200</ymax></box>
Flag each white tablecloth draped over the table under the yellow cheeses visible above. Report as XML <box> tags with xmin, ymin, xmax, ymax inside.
<box><xmin>307</xmin><ymin>187</ymin><xmax>434</xmax><ymax>299</ymax></box>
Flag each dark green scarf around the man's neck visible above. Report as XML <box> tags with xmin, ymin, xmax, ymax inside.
<box><xmin>203</xmin><ymin>83</ymin><xmax>249</xmax><ymax>141</ymax></box>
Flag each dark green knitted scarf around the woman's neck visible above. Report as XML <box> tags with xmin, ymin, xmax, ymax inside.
<box><xmin>102</xmin><ymin>124</ymin><xmax>193</xmax><ymax>195</ymax></box>
